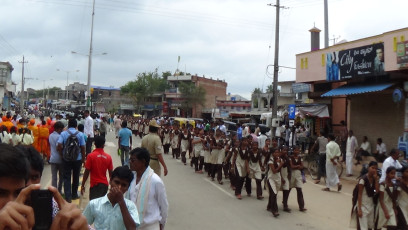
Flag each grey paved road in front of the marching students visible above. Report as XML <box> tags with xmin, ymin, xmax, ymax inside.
<box><xmin>42</xmin><ymin>133</ymin><xmax>355</xmax><ymax>230</ymax></box>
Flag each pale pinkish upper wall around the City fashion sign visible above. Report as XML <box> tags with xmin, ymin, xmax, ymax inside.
<box><xmin>296</xmin><ymin>28</ymin><xmax>408</xmax><ymax>82</ymax></box>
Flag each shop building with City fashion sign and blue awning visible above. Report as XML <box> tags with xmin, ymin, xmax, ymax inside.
<box><xmin>296</xmin><ymin>28</ymin><xmax>408</xmax><ymax>151</ymax></box>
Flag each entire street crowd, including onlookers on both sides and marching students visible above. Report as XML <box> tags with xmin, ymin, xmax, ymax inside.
<box><xmin>0</xmin><ymin>111</ymin><xmax>408</xmax><ymax>230</ymax></box>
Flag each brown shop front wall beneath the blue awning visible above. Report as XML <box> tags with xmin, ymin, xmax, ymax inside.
<box><xmin>349</xmin><ymin>91</ymin><xmax>405</xmax><ymax>152</ymax></box>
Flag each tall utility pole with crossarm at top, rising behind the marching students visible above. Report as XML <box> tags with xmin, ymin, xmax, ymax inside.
<box><xmin>268</xmin><ymin>0</ymin><xmax>285</xmax><ymax>142</ymax></box>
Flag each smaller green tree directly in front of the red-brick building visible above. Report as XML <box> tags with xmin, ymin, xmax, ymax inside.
<box><xmin>179</xmin><ymin>82</ymin><xmax>207</xmax><ymax>117</ymax></box>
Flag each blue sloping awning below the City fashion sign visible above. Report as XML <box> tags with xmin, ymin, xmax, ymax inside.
<box><xmin>322</xmin><ymin>83</ymin><xmax>393</xmax><ymax>97</ymax></box>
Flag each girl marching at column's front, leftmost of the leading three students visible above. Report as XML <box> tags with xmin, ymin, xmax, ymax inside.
<box><xmin>266</xmin><ymin>150</ymin><xmax>283</xmax><ymax>217</ymax></box>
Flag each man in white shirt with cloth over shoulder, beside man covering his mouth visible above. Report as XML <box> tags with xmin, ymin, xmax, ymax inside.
<box><xmin>125</xmin><ymin>148</ymin><xmax>169</xmax><ymax>230</ymax></box>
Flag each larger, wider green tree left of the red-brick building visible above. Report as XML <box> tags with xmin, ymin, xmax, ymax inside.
<box><xmin>120</xmin><ymin>69</ymin><xmax>168</xmax><ymax>111</ymax></box>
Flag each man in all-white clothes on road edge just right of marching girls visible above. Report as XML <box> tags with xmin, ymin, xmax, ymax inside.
<box><xmin>323</xmin><ymin>134</ymin><xmax>342</xmax><ymax>191</ymax></box>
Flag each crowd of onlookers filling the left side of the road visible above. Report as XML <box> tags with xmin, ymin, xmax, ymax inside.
<box><xmin>0</xmin><ymin>110</ymin><xmax>168</xmax><ymax>230</ymax></box>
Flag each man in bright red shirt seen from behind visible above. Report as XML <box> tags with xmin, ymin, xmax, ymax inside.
<box><xmin>81</xmin><ymin>136</ymin><xmax>113</xmax><ymax>200</ymax></box>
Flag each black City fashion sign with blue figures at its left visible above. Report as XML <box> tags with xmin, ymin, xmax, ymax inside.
<box><xmin>326</xmin><ymin>43</ymin><xmax>385</xmax><ymax>81</ymax></box>
